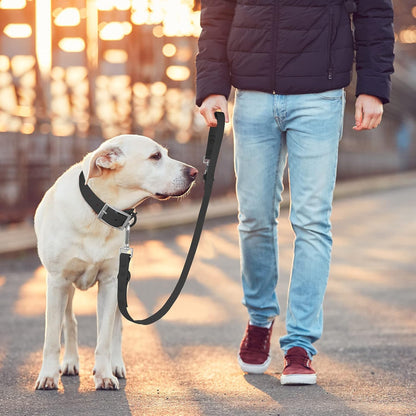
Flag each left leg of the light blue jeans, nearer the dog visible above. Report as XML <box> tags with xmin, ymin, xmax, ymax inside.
<box><xmin>234</xmin><ymin>91</ymin><xmax>286</xmax><ymax>327</ymax></box>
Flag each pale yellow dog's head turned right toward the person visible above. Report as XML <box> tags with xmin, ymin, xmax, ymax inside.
<box><xmin>83</xmin><ymin>134</ymin><xmax>198</xmax><ymax>206</ymax></box>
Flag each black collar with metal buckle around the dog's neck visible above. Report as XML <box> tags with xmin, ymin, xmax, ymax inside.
<box><xmin>79</xmin><ymin>171</ymin><xmax>137</xmax><ymax>229</ymax></box>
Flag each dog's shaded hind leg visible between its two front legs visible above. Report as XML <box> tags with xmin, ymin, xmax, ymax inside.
<box><xmin>61</xmin><ymin>285</ymin><xmax>79</xmax><ymax>376</ymax></box>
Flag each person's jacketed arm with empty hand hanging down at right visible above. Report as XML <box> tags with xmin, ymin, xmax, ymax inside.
<box><xmin>353</xmin><ymin>0</ymin><xmax>394</xmax><ymax>130</ymax></box>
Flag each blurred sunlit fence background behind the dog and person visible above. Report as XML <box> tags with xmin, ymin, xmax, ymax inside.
<box><xmin>0</xmin><ymin>0</ymin><xmax>416</xmax><ymax>223</ymax></box>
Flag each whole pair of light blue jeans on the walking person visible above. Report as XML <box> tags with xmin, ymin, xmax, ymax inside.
<box><xmin>234</xmin><ymin>89</ymin><xmax>345</xmax><ymax>356</ymax></box>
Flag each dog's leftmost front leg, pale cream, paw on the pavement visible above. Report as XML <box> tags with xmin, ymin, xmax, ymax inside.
<box><xmin>35</xmin><ymin>273</ymin><xmax>69</xmax><ymax>390</ymax></box>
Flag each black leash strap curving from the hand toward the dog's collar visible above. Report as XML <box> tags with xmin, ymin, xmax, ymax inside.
<box><xmin>117</xmin><ymin>112</ymin><xmax>225</xmax><ymax>325</ymax></box>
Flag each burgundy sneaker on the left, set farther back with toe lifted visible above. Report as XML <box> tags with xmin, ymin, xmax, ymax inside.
<box><xmin>238</xmin><ymin>321</ymin><xmax>274</xmax><ymax>374</ymax></box>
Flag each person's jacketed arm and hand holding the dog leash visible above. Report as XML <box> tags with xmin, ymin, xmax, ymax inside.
<box><xmin>196</xmin><ymin>0</ymin><xmax>236</xmax><ymax>125</ymax></box>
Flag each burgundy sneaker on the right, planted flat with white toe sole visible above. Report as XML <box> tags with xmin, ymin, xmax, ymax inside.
<box><xmin>280</xmin><ymin>347</ymin><xmax>316</xmax><ymax>384</ymax></box>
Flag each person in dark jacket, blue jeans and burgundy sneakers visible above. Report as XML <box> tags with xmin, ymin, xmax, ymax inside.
<box><xmin>196</xmin><ymin>0</ymin><xmax>394</xmax><ymax>384</ymax></box>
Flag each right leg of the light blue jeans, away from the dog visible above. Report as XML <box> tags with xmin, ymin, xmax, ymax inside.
<box><xmin>280</xmin><ymin>90</ymin><xmax>345</xmax><ymax>357</ymax></box>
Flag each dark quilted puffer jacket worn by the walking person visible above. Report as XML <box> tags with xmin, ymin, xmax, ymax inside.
<box><xmin>196</xmin><ymin>0</ymin><xmax>394</xmax><ymax>106</ymax></box>
